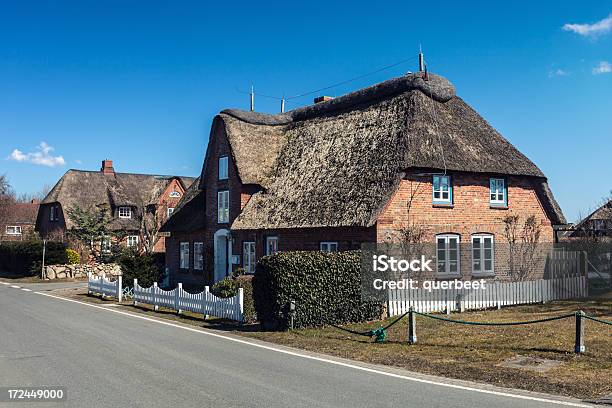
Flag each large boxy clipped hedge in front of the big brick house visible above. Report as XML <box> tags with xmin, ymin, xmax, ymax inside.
<box><xmin>253</xmin><ymin>251</ymin><xmax>382</xmax><ymax>330</ymax></box>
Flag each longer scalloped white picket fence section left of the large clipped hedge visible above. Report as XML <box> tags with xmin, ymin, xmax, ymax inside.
<box><xmin>134</xmin><ymin>279</ymin><xmax>244</xmax><ymax>322</ymax></box>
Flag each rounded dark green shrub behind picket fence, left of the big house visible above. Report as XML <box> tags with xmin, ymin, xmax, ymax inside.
<box><xmin>115</xmin><ymin>248</ymin><xmax>163</xmax><ymax>288</ymax></box>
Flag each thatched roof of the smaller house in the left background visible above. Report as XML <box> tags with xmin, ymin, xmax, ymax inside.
<box><xmin>41</xmin><ymin>169</ymin><xmax>195</xmax><ymax>230</ymax></box>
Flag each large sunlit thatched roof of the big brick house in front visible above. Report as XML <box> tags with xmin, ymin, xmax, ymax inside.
<box><xmin>208</xmin><ymin>73</ymin><xmax>564</xmax><ymax>229</ymax></box>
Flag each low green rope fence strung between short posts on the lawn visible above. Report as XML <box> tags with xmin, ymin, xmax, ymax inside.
<box><xmin>331</xmin><ymin>308</ymin><xmax>612</xmax><ymax>353</ymax></box>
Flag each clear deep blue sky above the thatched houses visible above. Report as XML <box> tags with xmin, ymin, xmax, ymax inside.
<box><xmin>0</xmin><ymin>0</ymin><xmax>612</xmax><ymax>221</ymax></box>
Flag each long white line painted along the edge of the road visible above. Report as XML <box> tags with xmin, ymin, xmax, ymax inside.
<box><xmin>34</xmin><ymin>292</ymin><xmax>593</xmax><ymax>408</ymax></box>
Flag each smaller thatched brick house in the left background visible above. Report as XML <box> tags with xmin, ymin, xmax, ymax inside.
<box><xmin>36</xmin><ymin>160</ymin><xmax>194</xmax><ymax>252</ymax></box>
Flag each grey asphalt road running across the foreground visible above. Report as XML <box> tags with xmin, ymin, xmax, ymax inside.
<box><xmin>0</xmin><ymin>284</ymin><xmax>592</xmax><ymax>408</ymax></box>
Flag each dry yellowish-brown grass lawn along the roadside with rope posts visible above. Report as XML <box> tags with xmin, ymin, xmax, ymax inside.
<box><xmin>55</xmin><ymin>289</ymin><xmax>612</xmax><ymax>398</ymax></box>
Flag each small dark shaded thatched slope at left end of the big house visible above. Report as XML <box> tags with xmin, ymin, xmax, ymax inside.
<box><xmin>160</xmin><ymin>179</ymin><xmax>206</xmax><ymax>232</ymax></box>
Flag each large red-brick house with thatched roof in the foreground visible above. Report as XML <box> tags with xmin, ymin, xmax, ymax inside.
<box><xmin>162</xmin><ymin>72</ymin><xmax>565</xmax><ymax>284</ymax></box>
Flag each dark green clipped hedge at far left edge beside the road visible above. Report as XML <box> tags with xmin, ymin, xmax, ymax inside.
<box><xmin>0</xmin><ymin>240</ymin><xmax>68</xmax><ymax>276</ymax></box>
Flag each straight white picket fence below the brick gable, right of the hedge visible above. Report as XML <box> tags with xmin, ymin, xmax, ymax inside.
<box><xmin>387</xmin><ymin>276</ymin><xmax>587</xmax><ymax>317</ymax></box>
